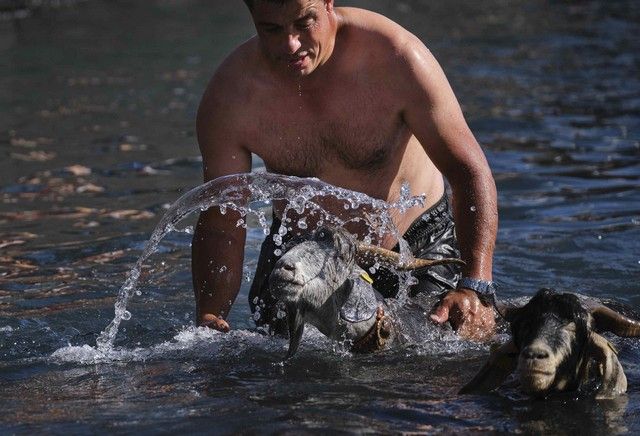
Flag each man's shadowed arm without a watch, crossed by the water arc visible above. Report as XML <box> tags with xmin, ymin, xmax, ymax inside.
<box><xmin>191</xmin><ymin>71</ymin><xmax>251</xmax><ymax>331</ymax></box>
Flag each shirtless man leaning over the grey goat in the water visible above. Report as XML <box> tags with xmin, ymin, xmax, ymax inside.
<box><xmin>192</xmin><ymin>0</ymin><xmax>497</xmax><ymax>337</ymax></box>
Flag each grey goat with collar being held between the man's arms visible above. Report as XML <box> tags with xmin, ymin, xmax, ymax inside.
<box><xmin>269</xmin><ymin>227</ymin><xmax>464</xmax><ymax>359</ymax></box>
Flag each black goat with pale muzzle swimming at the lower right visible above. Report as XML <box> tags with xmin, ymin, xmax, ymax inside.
<box><xmin>460</xmin><ymin>289</ymin><xmax>640</xmax><ymax>399</ymax></box>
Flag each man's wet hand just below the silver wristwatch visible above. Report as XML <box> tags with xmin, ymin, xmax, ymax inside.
<box><xmin>430</xmin><ymin>289</ymin><xmax>496</xmax><ymax>341</ymax></box>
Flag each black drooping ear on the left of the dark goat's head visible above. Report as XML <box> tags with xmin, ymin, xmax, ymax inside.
<box><xmin>458</xmin><ymin>340</ymin><xmax>518</xmax><ymax>394</ymax></box>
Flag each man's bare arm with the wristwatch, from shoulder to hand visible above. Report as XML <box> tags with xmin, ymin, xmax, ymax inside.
<box><xmin>401</xmin><ymin>38</ymin><xmax>498</xmax><ymax>339</ymax></box>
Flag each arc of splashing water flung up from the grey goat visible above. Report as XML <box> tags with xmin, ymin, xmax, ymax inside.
<box><xmin>96</xmin><ymin>173</ymin><xmax>425</xmax><ymax>354</ymax></box>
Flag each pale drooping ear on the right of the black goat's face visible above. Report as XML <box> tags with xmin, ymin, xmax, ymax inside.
<box><xmin>588</xmin><ymin>332</ymin><xmax>627</xmax><ymax>399</ymax></box>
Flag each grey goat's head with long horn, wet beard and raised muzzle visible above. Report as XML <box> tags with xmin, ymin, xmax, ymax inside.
<box><xmin>269</xmin><ymin>227</ymin><xmax>461</xmax><ymax>357</ymax></box>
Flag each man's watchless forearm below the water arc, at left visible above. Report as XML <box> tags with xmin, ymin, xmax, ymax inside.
<box><xmin>191</xmin><ymin>213</ymin><xmax>246</xmax><ymax>325</ymax></box>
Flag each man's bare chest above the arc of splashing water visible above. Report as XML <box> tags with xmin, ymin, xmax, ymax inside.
<box><xmin>242</xmin><ymin>80</ymin><xmax>409</xmax><ymax>176</ymax></box>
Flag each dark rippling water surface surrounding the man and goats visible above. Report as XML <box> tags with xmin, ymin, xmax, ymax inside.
<box><xmin>0</xmin><ymin>0</ymin><xmax>640</xmax><ymax>434</ymax></box>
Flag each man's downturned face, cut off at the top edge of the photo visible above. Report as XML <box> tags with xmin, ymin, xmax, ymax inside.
<box><xmin>251</xmin><ymin>0</ymin><xmax>335</xmax><ymax>77</ymax></box>
